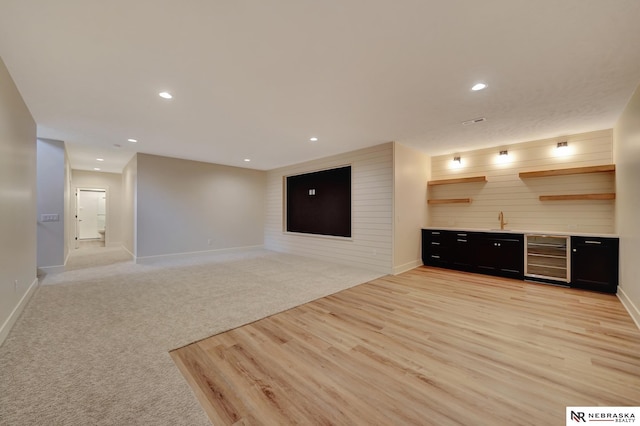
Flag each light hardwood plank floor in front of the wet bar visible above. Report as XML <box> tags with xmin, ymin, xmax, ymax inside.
<box><xmin>171</xmin><ymin>267</ymin><xmax>640</xmax><ymax>426</ymax></box>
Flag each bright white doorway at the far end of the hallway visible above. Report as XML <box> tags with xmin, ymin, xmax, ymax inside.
<box><xmin>76</xmin><ymin>188</ymin><xmax>107</xmax><ymax>248</ymax></box>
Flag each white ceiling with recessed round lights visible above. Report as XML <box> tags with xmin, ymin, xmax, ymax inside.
<box><xmin>0</xmin><ymin>0</ymin><xmax>640</xmax><ymax>172</ymax></box>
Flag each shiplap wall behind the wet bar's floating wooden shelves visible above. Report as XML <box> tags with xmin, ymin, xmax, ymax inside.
<box><xmin>428</xmin><ymin>129</ymin><xmax>615</xmax><ymax>233</ymax></box>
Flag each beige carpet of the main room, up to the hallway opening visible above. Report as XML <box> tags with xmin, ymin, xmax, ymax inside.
<box><xmin>0</xmin><ymin>250</ymin><xmax>380</xmax><ymax>425</ymax></box>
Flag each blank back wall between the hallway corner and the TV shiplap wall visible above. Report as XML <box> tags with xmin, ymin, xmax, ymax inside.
<box><xmin>136</xmin><ymin>154</ymin><xmax>266</xmax><ymax>262</ymax></box>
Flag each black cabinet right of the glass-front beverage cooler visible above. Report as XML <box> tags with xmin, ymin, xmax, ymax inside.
<box><xmin>571</xmin><ymin>237</ymin><xmax>619</xmax><ymax>293</ymax></box>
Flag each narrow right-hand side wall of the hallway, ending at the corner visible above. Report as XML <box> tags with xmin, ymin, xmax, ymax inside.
<box><xmin>121</xmin><ymin>154</ymin><xmax>138</xmax><ymax>259</ymax></box>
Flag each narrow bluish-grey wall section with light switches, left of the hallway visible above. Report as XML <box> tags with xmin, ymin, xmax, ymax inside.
<box><xmin>37</xmin><ymin>139</ymin><xmax>66</xmax><ymax>273</ymax></box>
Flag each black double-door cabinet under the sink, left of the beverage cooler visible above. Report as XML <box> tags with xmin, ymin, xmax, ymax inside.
<box><xmin>472</xmin><ymin>232</ymin><xmax>524</xmax><ymax>279</ymax></box>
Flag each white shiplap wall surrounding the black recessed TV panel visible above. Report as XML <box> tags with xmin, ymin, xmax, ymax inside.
<box><xmin>264</xmin><ymin>143</ymin><xmax>393</xmax><ymax>273</ymax></box>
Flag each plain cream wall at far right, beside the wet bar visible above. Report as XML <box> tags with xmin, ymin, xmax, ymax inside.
<box><xmin>614</xmin><ymin>86</ymin><xmax>640</xmax><ymax>327</ymax></box>
